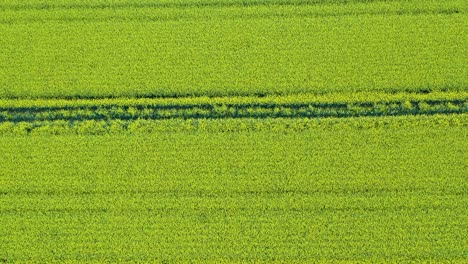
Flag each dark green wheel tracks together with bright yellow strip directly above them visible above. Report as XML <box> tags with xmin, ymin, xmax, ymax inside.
<box><xmin>0</xmin><ymin>92</ymin><xmax>468</xmax><ymax>125</ymax></box>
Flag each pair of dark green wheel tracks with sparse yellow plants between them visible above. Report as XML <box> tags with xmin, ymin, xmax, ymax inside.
<box><xmin>0</xmin><ymin>96</ymin><xmax>468</xmax><ymax>122</ymax></box>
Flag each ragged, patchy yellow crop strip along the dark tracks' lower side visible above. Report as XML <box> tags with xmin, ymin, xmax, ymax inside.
<box><xmin>0</xmin><ymin>113</ymin><xmax>468</xmax><ymax>136</ymax></box>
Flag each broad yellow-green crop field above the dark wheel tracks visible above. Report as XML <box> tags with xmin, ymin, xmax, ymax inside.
<box><xmin>0</xmin><ymin>0</ymin><xmax>468</xmax><ymax>98</ymax></box>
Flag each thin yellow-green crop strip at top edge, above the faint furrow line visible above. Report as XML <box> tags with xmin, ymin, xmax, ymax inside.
<box><xmin>0</xmin><ymin>0</ymin><xmax>467</xmax><ymax>24</ymax></box>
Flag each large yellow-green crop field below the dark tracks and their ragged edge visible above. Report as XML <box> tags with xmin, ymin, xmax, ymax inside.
<box><xmin>0</xmin><ymin>117</ymin><xmax>468</xmax><ymax>263</ymax></box>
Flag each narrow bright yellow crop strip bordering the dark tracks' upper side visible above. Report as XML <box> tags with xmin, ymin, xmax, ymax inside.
<box><xmin>0</xmin><ymin>90</ymin><xmax>468</xmax><ymax>109</ymax></box>
